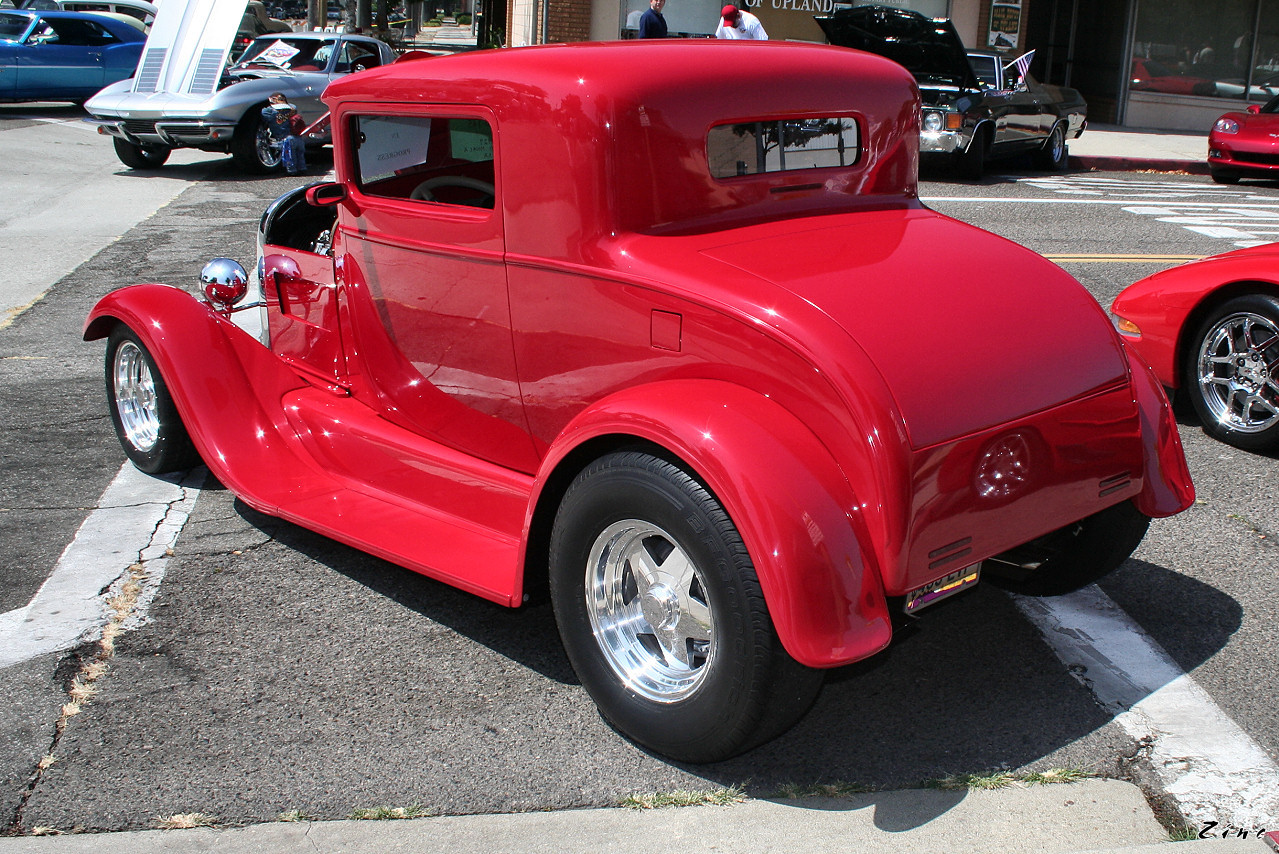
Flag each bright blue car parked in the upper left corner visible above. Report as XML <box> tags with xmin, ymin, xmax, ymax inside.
<box><xmin>0</xmin><ymin>9</ymin><xmax>146</xmax><ymax>104</ymax></box>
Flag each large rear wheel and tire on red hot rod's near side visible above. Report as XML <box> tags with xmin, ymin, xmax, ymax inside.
<box><xmin>550</xmin><ymin>453</ymin><xmax>822</xmax><ymax>762</ymax></box>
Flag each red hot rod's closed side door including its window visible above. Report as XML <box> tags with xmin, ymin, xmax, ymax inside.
<box><xmin>334</xmin><ymin>106</ymin><xmax>537</xmax><ymax>472</ymax></box>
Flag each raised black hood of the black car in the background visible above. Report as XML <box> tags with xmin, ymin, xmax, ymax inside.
<box><xmin>817</xmin><ymin>6</ymin><xmax>980</xmax><ymax>89</ymax></box>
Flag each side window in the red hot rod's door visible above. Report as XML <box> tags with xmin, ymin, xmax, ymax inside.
<box><xmin>352</xmin><ymin>115</ymin><xmax>495</xmax><ymax>210</ymax></box>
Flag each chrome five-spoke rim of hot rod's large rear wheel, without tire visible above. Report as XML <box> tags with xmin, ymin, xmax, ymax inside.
<box><xmin>586</xmin><ymin>519</ymin><xmax>715</xmax><ymax>703</ymax></box>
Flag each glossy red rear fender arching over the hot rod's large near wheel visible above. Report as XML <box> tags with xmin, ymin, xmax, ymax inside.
<box><xmin>533</xmin><ymin>380</ymin><xmax>891</xmax><ymax>667</ymax></box>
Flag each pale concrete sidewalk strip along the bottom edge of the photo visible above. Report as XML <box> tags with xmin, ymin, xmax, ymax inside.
<box><xmin>0</xmin><ymin>780</ymin><xmax>1271</xmax><ymax>854</ymax></box>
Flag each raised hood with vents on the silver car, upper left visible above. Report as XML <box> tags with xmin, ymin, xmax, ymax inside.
<box><xmin>123</xmin><ymin>0</ymin><xmax>244</xmax><ymax>96</ymax></box>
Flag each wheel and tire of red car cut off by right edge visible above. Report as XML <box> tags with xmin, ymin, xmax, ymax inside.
<box><xmin>1182</xmin><ymin>294</ymin><xmax>1279</xmax><ymax>451</ymax></box>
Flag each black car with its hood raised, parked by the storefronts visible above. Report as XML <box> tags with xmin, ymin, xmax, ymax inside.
<box><xmin>817</xmin><ymin>6</ymin><xmax>1087</xmax><ymax>179</ymax></box>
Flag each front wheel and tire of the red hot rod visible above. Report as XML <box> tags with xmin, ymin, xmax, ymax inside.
<box><xmin>106</xmin><ymin>325</ymin><xmax>200</xmax><ymax>474</ymax></box>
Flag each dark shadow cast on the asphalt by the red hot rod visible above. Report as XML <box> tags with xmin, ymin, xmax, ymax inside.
<box><xmin>227</xmin><ymin>485</ymin><xmax>1242</xmax><ymax>802</ymax></box>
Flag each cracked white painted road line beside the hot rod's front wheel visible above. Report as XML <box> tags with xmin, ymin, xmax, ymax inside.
<box><xmin>0</xmin><ymin>463</ymin><xmax>207</xmax><ymax>667</ymax></box>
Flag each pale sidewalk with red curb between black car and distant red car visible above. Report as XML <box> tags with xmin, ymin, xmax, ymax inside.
<box><xmin>1069</xmin><ymin>124</ymin><xmax>1207</xmax><ymax>175</ymax></box>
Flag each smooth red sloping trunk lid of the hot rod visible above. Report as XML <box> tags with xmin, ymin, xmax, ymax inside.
<box><xmin>701</xmin><ymin>208</ymin><xmax>1127</xmax><ymax>447</ymax></box>
